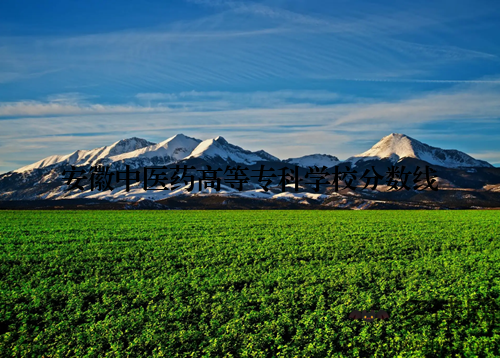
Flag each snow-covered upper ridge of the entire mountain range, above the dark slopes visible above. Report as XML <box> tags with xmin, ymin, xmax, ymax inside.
<box><xmin>7</xmin><ymin>133</ymin><xmax>493</xmax><ymax>173</ymax></box>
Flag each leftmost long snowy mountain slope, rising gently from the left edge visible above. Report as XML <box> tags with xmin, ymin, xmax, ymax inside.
<box><xmin>14</xmin><ymin>137</ymin><xmax>154</xmax><ymax>173</ymax></box>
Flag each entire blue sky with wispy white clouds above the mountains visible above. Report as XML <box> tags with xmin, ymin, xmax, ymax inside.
<box><xmin>0</xmin><ymin>0</ymin><xmax>500</xmax><ymax>173</ymax></box>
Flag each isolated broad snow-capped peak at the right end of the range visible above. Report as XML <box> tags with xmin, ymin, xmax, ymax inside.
<box><xmin>346</xmin><ymin>133</ymin><xmax>493</xmax><ymax>168</ymax></box>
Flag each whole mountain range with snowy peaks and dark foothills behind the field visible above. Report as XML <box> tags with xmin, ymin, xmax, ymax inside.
<box><xmin>0</xmin><ymin>133</ymin><xmax>500</xmax><ymax>209</ymax></box>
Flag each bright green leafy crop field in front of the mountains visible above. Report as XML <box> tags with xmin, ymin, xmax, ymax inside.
<box><xmin>0</xmin><ymin>211</ymin><xmax>500</xmax><ymax>358</ymax></box>
